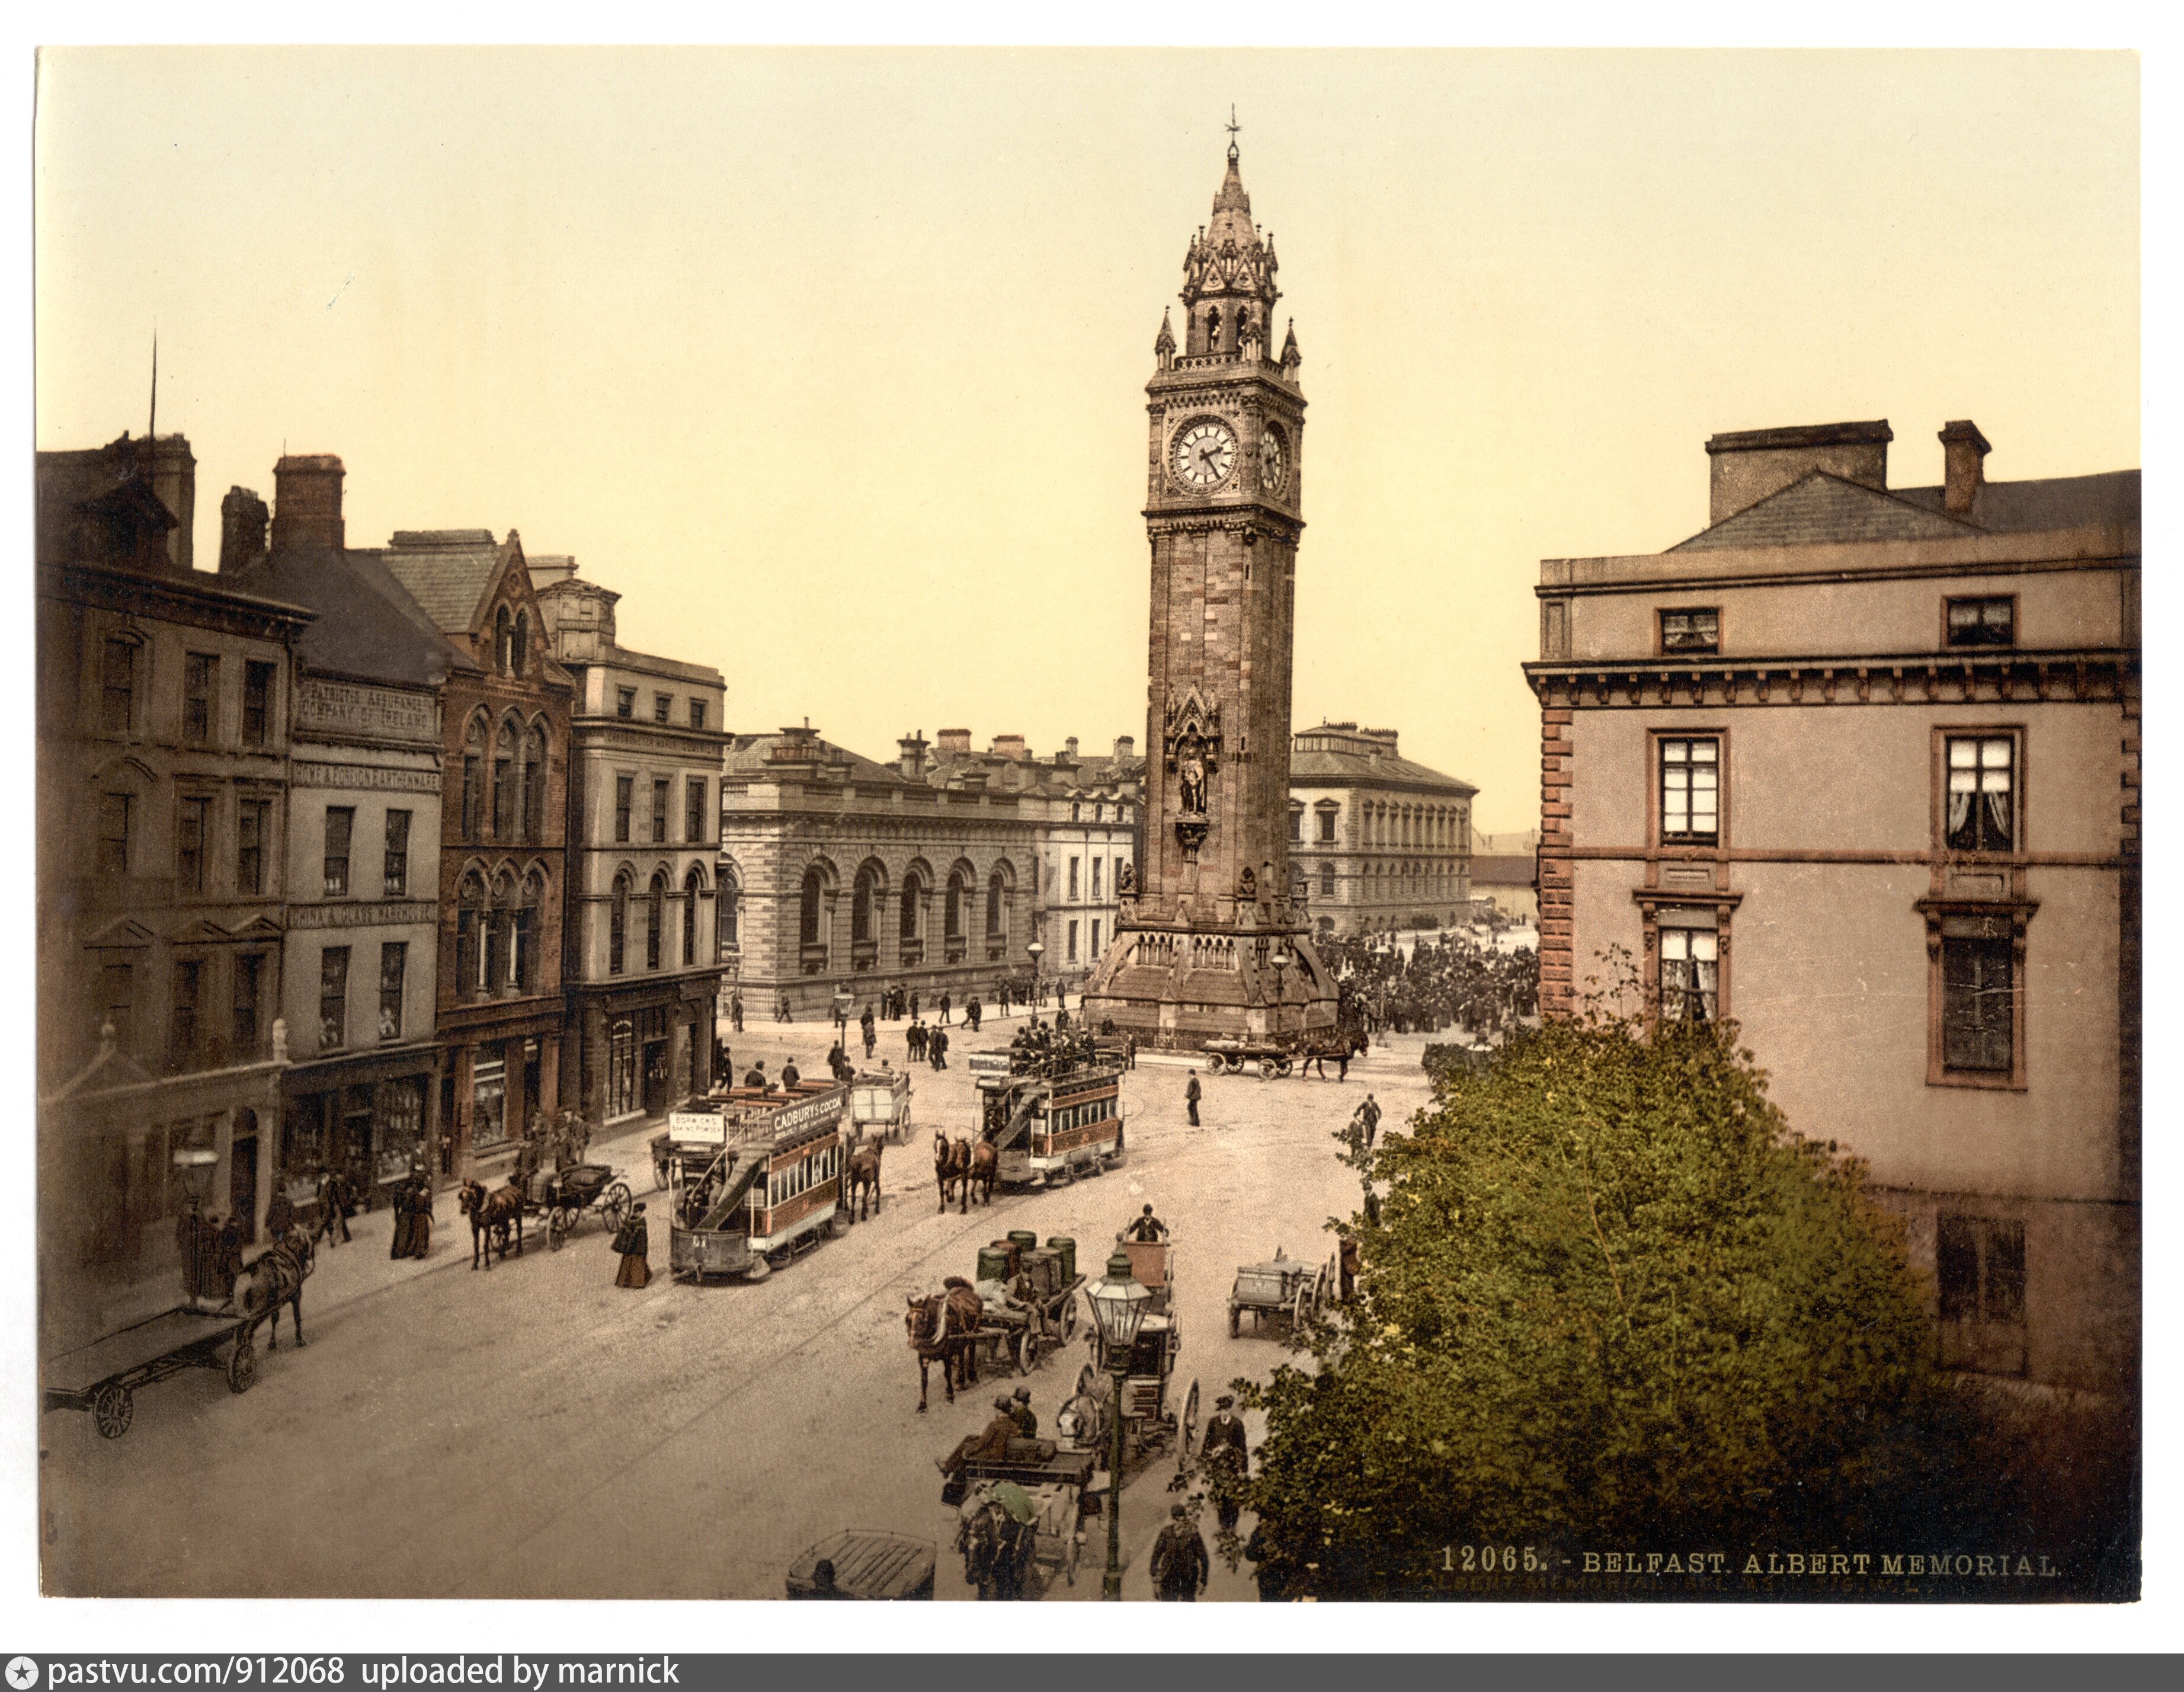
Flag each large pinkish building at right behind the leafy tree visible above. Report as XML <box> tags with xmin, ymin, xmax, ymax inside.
<box><xmin>1525</xmin><ymin>421</ymin><xmax>2140</xmax><ymax>1391</ymax></box>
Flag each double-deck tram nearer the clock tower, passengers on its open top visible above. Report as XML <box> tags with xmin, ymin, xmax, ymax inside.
<box><xmin>970</xmin><ymin>1039</ymin><xmax>1125</xmax><ymax>1185</ymax></box>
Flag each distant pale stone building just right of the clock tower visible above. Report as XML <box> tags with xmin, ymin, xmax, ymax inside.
<box><xmin>1289</xmin><ymin>722</ymin><xmax>1476</xmax><ymax>935</ymax></box>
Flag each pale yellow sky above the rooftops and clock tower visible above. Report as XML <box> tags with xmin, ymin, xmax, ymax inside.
<box><xmin>35</xmin><ymin>48</ymin><xmax>2138</xmax><ymax>830</ymax></box>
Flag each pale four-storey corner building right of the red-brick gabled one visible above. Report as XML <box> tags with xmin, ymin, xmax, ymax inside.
<box><xmin>531</xmin><ymin>556</ymin><xmax>727</xmax><ymax>1122</ymax></box>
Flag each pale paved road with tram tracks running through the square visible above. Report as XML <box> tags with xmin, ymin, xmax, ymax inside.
<box><xmin>41</xmin><ymin>1028</ymin><xmax>1426</xmax><ymax>1598</ymax></box>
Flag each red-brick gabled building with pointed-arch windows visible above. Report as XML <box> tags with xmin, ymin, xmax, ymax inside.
<box><xmin>375</xmin><ymin>526</ymin><xmax>574</xmax><ymax>1175</ymax></box>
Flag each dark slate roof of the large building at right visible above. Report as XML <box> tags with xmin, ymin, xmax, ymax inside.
<box><xmin>1669</xmin><ymin>469</ymin><xmax>2138</xmax><ymax>552</ymax></box>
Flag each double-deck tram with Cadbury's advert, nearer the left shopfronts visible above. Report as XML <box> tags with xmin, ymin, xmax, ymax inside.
<box><xmin>668</xmin><ymin>1083</ymin><xmax>850</xmax><ymax>1281</ymax></box>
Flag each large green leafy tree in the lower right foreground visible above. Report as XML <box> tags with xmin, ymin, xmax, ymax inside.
<box><xmin>1238</xmin><ymin>991</ymin><xmax>1964</xmax><ymax>1596</ymax></box>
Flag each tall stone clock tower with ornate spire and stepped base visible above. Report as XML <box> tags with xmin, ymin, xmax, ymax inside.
<box><xmin>1085</xmin><ymin>137</ymin><xmax>1334</xmax><ymax>1050</ymax></box>
